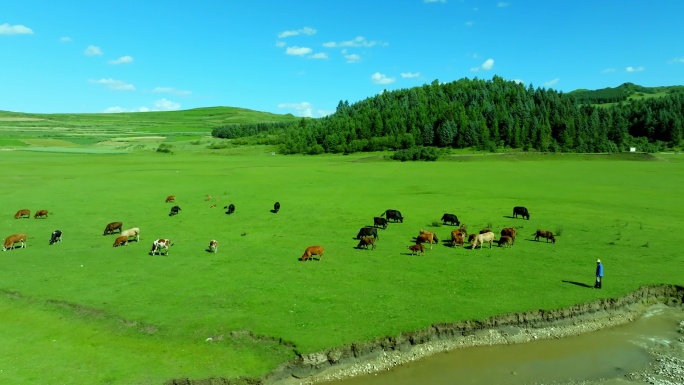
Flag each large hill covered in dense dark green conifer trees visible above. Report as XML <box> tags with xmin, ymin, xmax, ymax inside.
<box><xmin>212</xmin><ymin>76</ymin><xmax>684</xmax><ymax>154</ymax></box>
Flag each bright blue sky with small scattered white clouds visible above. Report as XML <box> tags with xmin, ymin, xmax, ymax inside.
<box><xmin>0</xmin><ymin>0</ymin><xmax>684</xmax><ymax>117</ymax></box>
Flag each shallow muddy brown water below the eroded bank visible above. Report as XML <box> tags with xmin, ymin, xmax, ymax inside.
<box><xmin>330</xmin><ymin>306</ymin><xmax>684</xmax><ymax>385</ymax></box>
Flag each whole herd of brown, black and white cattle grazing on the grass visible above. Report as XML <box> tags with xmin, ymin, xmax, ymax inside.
<box><xmin>2</xmin><ymin>202</ymin><xmax>556</xmax><ymax>261</ymax></box>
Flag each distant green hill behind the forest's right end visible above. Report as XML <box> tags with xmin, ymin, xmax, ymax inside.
<box><xmin>568</xmin><ymin>83</ymin><xmax>684</xmax><ymax>104</ymax></box>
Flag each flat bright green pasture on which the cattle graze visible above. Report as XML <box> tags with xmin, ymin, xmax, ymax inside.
<box><xmin>0</xmin><ymin>146</ymin><xmax>684</xmax><ymax>384</ymax></box>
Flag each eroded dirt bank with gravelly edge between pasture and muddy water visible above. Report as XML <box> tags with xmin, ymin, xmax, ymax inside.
<box><xmin>167</xmin><ymin>285</ymin><xmax>684</xmax><ymax>385</ymax></box>
